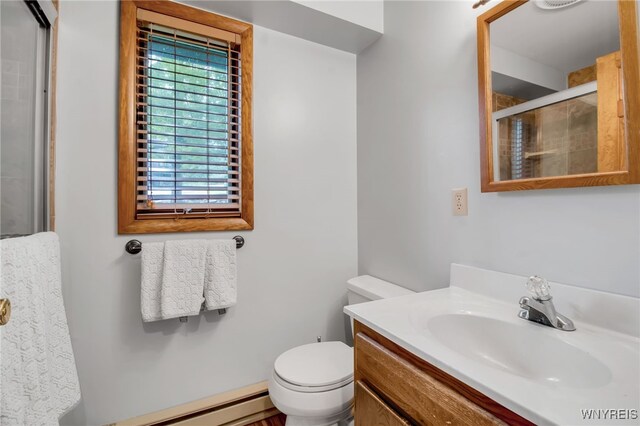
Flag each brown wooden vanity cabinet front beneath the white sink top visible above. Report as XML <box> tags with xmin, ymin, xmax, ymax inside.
<box><xmin>354</xmin><ymin>321</ymin><xmax>533</xmax><ymax>426</ymax></box>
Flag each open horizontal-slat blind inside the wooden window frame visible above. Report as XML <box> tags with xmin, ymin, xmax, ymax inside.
<box><xmin>136</xmin><ymin>20</ymin><xmax>242</xmax><ymax>219</ymax></box>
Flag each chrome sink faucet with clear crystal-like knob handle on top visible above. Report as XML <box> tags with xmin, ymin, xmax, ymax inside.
<box><xmin>518</xmin><ymin>275</ymin><xmax>576</xmax><ymax>331</ymax></box>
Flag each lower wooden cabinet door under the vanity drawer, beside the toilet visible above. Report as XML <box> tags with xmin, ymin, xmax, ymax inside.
<box><xmin>354</xmin><ymin>380</ymin><xmax>409</xmax><ymax>426</ymax></box>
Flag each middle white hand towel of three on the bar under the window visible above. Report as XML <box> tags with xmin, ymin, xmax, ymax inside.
<box><xmin>159</xmin><ymin>240</ymin><xmax>207</xmax><ymax>319</ymax></box>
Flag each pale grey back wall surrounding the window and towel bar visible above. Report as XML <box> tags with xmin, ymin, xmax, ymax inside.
<box><xmin>56</xmin><ymin>1</ymin><xmax>357</xmax><ymax>425</ymax></box>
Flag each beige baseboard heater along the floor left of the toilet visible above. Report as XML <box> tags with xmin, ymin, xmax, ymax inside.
<box><xmin>109</xmin><ymin>382</ymin><xmax>279</xmax><ymax>426</ymax></box>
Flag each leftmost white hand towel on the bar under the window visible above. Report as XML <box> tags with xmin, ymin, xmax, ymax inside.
<box><xmin>140</xmin><ymin>243</ymin><xmax>164</xmax><ymax>322</ymax></box>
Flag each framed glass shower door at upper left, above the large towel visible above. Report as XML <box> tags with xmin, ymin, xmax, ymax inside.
<box><xmin>0</xmin><ymin>0</ymin><xmax>55</xmax><ymax>238</ymax></box>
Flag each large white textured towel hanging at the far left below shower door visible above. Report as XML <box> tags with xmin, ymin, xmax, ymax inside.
<box><xmin>0</xmin><ymin>232</ymin><xmax>80</xmax><ymax>425</ymax></box>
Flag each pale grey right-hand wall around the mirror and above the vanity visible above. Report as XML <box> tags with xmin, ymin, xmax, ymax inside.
<box><xmin>358</xmin><ymin>1</ymin><xmax>640</xmax><ymax>303</ymax></box>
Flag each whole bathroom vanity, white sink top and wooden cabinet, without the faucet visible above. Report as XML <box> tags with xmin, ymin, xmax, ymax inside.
<box><xmin>345</xmin><ymin>264</ymin><xmax>640</xmax><ymax>425</ymax></box>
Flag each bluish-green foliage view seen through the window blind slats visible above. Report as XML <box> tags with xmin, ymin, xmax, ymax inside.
<box><xmin>138</xmin><ymin>28</ymin><xmax>238</xmax><ymax>209</ymax></box>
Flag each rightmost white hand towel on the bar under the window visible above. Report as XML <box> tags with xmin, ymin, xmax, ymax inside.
<box><xmin>204</xmin><ymin>239</ymin><xmax>237</xmax><ymax>310</ymax></box>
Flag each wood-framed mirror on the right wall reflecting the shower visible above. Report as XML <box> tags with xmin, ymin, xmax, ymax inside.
<box><xmin>478</xmin><ymin>0</ymin><xmax>640</xmax><ymax>192</ymax></box>
